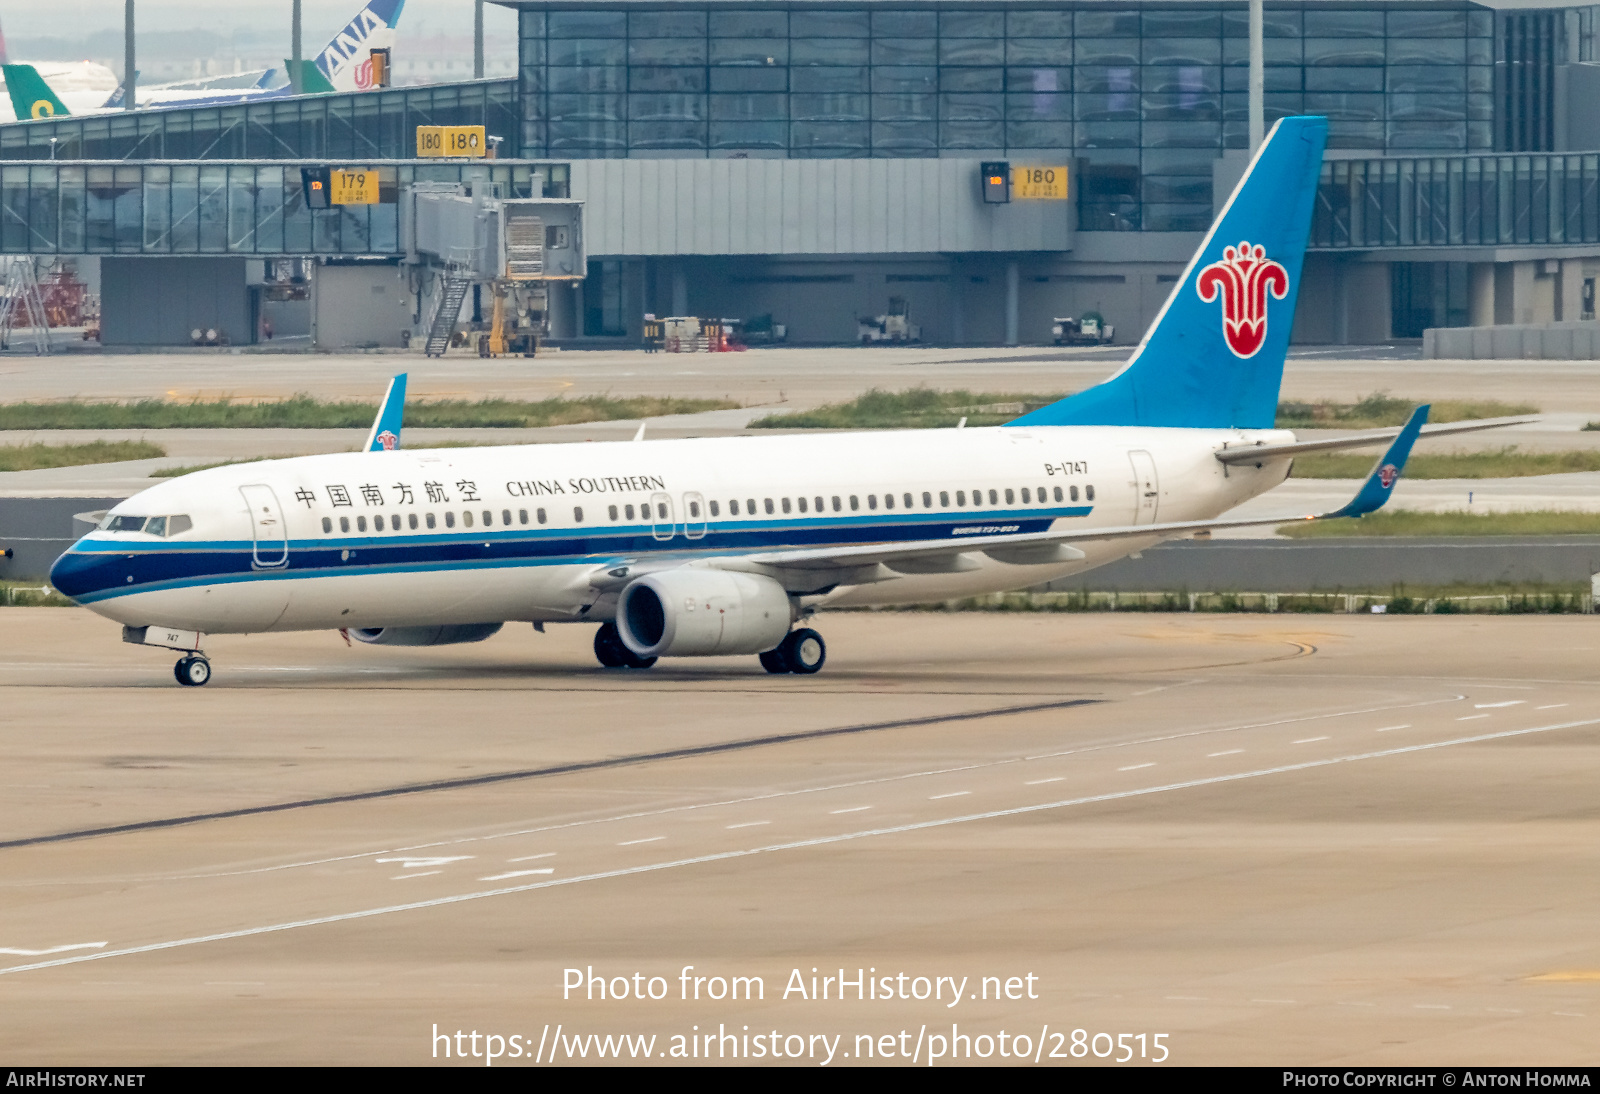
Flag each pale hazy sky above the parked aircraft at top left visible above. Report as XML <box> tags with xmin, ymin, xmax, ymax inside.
<box><xmin>0</xmin><ymin>0</ymin><xmax>517</xmax><ymax>46</ymax></box>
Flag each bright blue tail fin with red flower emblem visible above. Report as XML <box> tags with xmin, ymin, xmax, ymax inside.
<box><xmin>1008</xmin><ymin>118</ymin><xmax>1328</xmax><ymax>429</ymax></box>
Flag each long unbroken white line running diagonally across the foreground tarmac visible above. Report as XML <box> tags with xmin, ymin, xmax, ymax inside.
<box><xmin>0</xmin><ymin>718</ymin><xmax>1600</xmax><ymax>976</ymax></box>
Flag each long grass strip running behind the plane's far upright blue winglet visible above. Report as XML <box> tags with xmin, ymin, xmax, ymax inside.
<box><xmin>0</xmin><ymin>393</ymin><xmax>739</xmax><ymax>430</ymax></box>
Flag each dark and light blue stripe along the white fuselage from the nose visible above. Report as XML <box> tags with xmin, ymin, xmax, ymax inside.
<box><xmin>53</xmin><ymin>505</ymin><xmax>1093</xmax><ymax>605</ymax></box>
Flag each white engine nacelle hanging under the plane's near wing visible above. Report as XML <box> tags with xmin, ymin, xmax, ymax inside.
<box><xmin>616</xmin><ymin>569</ymin><xmax>794</xmax><ymax>657</ymax></box>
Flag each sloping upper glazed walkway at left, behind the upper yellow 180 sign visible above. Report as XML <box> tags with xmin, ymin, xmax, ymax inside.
<box><xmin>0</xmin><ymin>80</ymin><xmax>520</xmax><ymax>160</ymax></box>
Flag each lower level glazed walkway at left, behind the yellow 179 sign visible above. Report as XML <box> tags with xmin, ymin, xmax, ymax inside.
<box><xmin>0</xmin><ymin>160</ymin><xmax>570</xmax><ymax>256</ymax></box>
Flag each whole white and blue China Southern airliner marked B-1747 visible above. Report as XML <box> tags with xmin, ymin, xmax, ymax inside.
<box><xmin>51</xmin><ymin>118</ymin><xmax>1506</xmax><ymax>685</ymax></box>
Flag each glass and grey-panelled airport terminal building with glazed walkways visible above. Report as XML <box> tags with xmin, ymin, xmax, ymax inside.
<box><xmin>0</xmin><ymin>0</ymin><xmax>1600</xmax><ymax>344</ymax></box>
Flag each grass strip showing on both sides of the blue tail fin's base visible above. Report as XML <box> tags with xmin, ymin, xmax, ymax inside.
<box><xmin>750</xmin><ymin>387</ymin><xmax>1542</xmax><ymax>431</ymax></box>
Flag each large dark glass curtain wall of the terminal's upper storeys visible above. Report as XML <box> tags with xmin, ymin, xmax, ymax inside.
<box><xmin>518</xmin><ymin>0</ymin><xmax>1498</xmax><ymax>230</ymax></box>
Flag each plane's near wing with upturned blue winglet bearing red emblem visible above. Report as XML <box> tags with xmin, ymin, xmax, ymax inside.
<box><xmin>709</xmin><ymin>406</ymin><xmax>1429</xmax><ymax>587</ymax></box>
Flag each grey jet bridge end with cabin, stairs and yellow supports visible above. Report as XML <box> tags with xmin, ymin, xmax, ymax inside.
<box><xmin>400</xmin><ymin>179</ymin><xmax>589</xmax><ymax>357</ymax></box>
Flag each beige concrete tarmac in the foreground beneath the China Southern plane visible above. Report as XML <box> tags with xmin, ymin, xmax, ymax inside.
<box><xmin>0</xmin><ymin>608</ymin><xmax>1600</xmax><ymax>1067</ymax></box>
